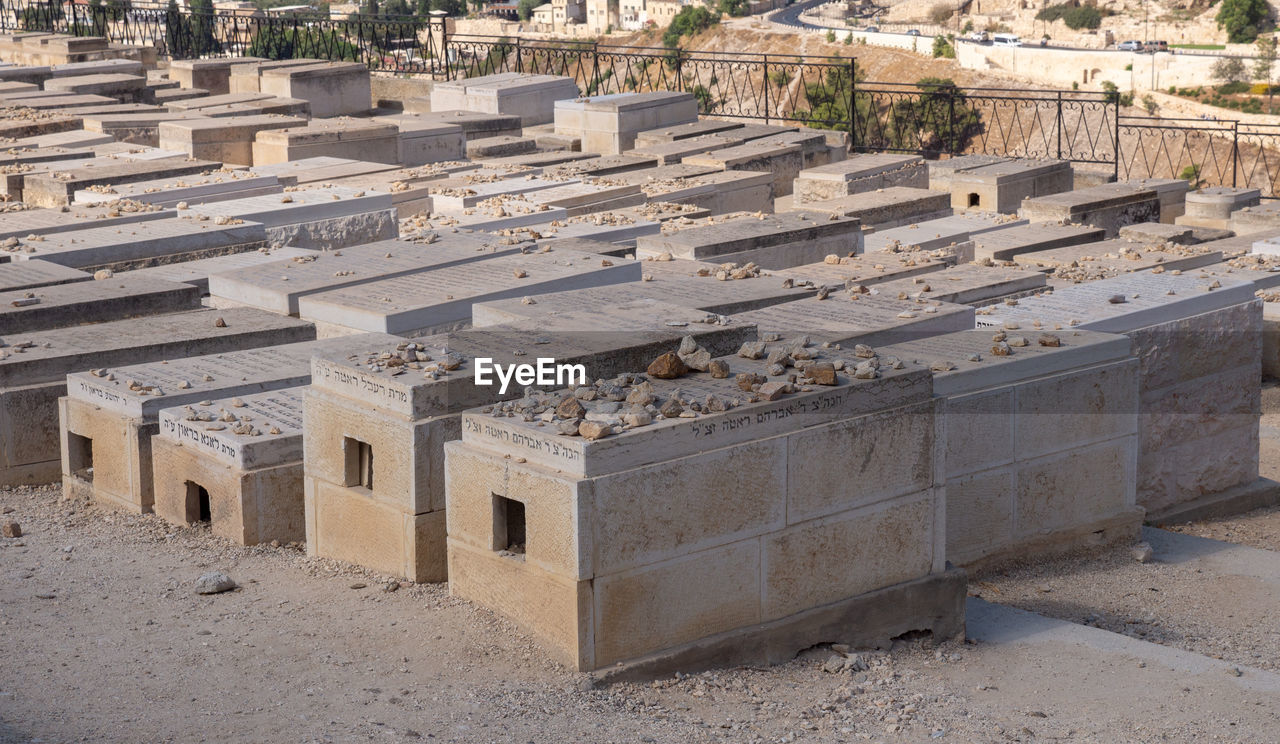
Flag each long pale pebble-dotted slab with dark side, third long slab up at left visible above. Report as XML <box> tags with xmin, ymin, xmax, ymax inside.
<box><xmin>12</xmin><ymin>216</ymin><xmax>268</xmax><ymax>271</ymax></box>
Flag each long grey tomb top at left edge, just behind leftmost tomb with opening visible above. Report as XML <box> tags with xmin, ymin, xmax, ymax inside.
<box><xmin>0</xmin><ymin>309</ymin><xmax>315</xmax><ymax>387</ymax></box>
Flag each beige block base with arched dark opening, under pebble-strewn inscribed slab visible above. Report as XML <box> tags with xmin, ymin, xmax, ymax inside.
<box><xmin>151</xmin><ymin>437</ymin><xmax>306</xmax><ymax>546</ymax></box>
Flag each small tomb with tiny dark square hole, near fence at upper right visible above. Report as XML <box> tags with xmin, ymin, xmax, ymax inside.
<box><xmin>951</xmin><ymin>159</ymin><xmax>1070</xmax><ymax>214</ymax></box>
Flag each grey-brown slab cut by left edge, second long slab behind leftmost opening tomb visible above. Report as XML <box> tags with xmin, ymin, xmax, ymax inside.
<box><xmin>0</xmin><ymin>277</ymin><xmax>200</xmax><ymax>337</ymax></box>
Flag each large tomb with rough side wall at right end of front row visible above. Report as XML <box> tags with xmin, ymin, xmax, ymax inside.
<box><xmin>978</xmin><ymin>271</ymin><xmax>1265</xmax><ymax>521</ymax></box>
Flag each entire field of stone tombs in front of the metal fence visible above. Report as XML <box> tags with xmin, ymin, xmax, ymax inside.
<box><xmin>0</xmin><ymin>56</ymin><xmax>1280</xmax><ymax>676</ymax></box>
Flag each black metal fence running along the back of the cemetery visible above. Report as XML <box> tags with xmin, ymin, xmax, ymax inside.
<box><xmin>0</xmin><ymin>0</ymin><xmax>1280</xmax><ymax>197</ymax></box>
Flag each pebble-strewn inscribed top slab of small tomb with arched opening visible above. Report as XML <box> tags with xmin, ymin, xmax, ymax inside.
<box><xmin>159</xmin><ymin>387</ymin><xmax>305</xmax><ymax>470</ymax></box>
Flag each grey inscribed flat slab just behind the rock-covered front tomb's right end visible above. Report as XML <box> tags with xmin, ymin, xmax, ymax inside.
<box><xmin>731</xmin><ymin>293</ymin><xmax>973</xmax><ymax>343</ymax></box>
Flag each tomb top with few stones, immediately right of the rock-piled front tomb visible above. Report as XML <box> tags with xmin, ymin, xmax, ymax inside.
<box><xmin>876</xmin><ymin>329</ymin><xmax>1130</xmax><ymax>394</ymax></box>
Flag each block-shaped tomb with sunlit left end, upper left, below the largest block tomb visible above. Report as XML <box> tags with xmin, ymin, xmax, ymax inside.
<box><xmin>253</xmin><ymin>118</ymin><xmax>399</xmax><ymax>165</ymax></box>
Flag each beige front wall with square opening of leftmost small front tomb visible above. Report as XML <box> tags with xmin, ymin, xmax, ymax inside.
<box><xmin>58</xmin><ymin>397</ymin><xmax>157</xmax><ymax>514</ymax></box>
